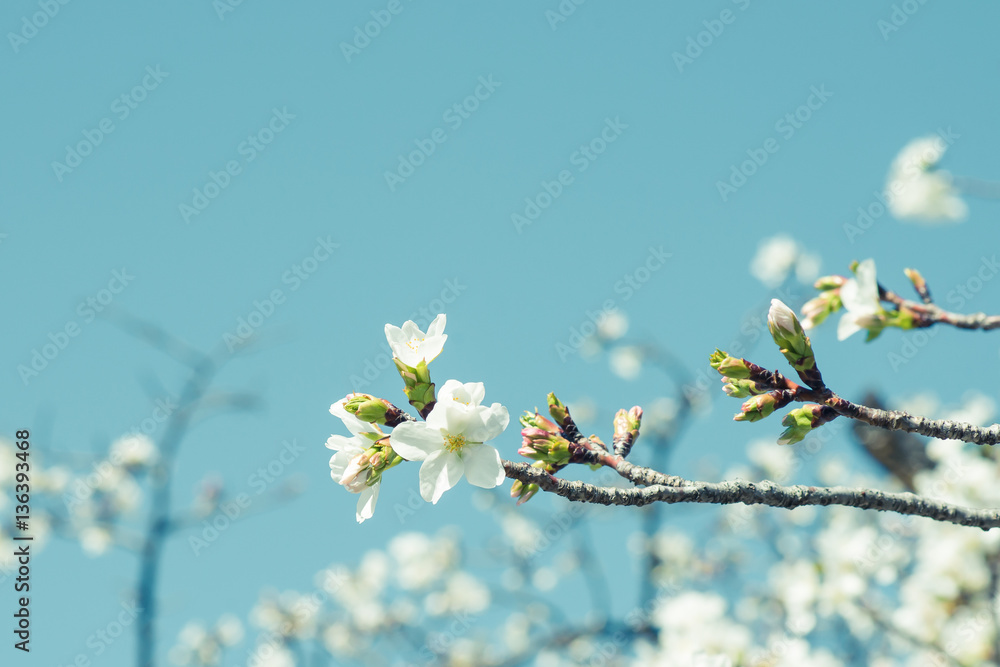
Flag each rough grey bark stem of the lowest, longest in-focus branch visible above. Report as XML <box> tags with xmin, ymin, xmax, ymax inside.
<box><xmin>502</xmin><ymin>460</ymin><xmax>1000</xmax><ymax>530</ymax></box>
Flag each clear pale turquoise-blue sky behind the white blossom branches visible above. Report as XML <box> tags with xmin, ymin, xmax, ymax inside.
<box><xmin>0</xmin><ymin>0</ymin><xmax>1000</xmax><ymax>665</ymax></box>
